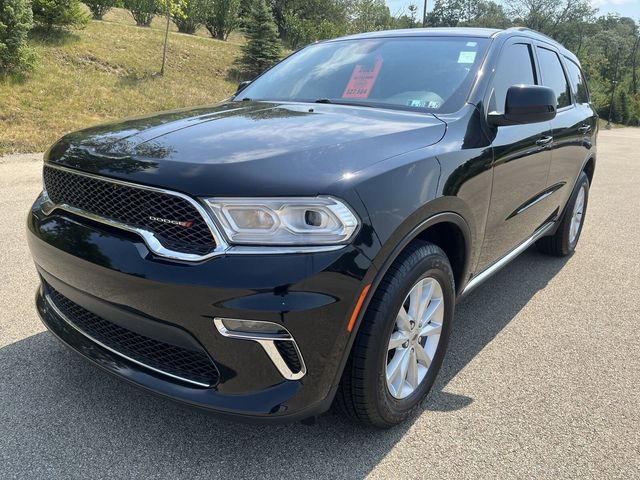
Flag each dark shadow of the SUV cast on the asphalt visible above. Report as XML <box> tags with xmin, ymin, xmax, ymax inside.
<box><xmin>0</xmin><ymin>246</ymin><xmax>566</xmax><ymax>479</ymax></box>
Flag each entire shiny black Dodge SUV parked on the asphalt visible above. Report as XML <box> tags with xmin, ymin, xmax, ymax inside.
<box><xmin>28</xmin><ymin>29</ymin><xmax>597</xmax><ymax>427</ymax></box>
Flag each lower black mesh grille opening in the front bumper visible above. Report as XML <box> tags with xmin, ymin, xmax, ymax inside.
<box><xmin>47</xmin><ymin>285</ymin><xmax>219</xmax><ymax>386</ymax></box>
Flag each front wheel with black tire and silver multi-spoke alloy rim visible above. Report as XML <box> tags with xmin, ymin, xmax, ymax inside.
<box><xmin>337</xmin><ymin>241</ymin><xmax>455</xmax><ymax>428</ymax></box>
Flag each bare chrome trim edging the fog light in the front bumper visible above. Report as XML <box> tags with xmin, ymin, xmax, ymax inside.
<box><xmin>213</xmin><ymin>317</ymin><xmax>307</xmax><ymax>380</ymax></box>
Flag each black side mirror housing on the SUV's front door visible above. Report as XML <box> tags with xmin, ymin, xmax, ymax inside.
<box><xmin>488</xmin><ymin>85</ymin><xmax>557</xmax><ymax>126</ymax></box>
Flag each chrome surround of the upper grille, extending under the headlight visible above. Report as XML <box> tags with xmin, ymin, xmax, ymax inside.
<box><xmin>41</xmin><ymin>163</ymin><xmax>350</xmax><ymax>262</ymax></box>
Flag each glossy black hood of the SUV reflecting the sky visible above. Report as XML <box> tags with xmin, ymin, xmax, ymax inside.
<box><xmin>46</xmin><ymin>101</ymin><xmax>446</xmax><ymax>196</ymax></box>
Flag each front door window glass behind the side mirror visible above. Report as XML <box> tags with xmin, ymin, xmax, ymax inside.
<box><xmin>490</xmin><ymin>43</ymin><xmax>536</xmax><ymax>112</ymax></box>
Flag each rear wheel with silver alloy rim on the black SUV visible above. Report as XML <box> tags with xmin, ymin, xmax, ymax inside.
<box><xmin>536</xmin><ymin>172</ymin><xmax>589</xmax><ymax>257</ymax></box>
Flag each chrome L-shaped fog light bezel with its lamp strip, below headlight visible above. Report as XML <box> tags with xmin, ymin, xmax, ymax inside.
<box><xmin>213</xmin><ymin>317</ymin><xmax>307</xmax><ymax>380</ymax></box>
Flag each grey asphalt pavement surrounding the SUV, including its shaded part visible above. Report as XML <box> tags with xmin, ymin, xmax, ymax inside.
<box><xmin>0</xmin><ymin>129</ymin><xmax>640</xmax><ymax>480</ymax></box>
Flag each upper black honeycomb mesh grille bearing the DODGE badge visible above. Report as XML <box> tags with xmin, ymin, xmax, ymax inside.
<box><xmin>44</xmin><ymin>166</ymin><xmax>216</xmax><ymax>255</ymax></box>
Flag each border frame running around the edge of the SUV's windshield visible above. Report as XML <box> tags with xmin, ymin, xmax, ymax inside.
<box><xmin>231</xmin><ymin>32</ymin><xmax>493</xmax><ymax>115</ymax></box>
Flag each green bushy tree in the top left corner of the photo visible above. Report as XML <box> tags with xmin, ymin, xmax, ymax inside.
<box><xmin>0</xmin><ymin>0</ymin><xmax>35</xmax><ymax>73</ymax></box>
